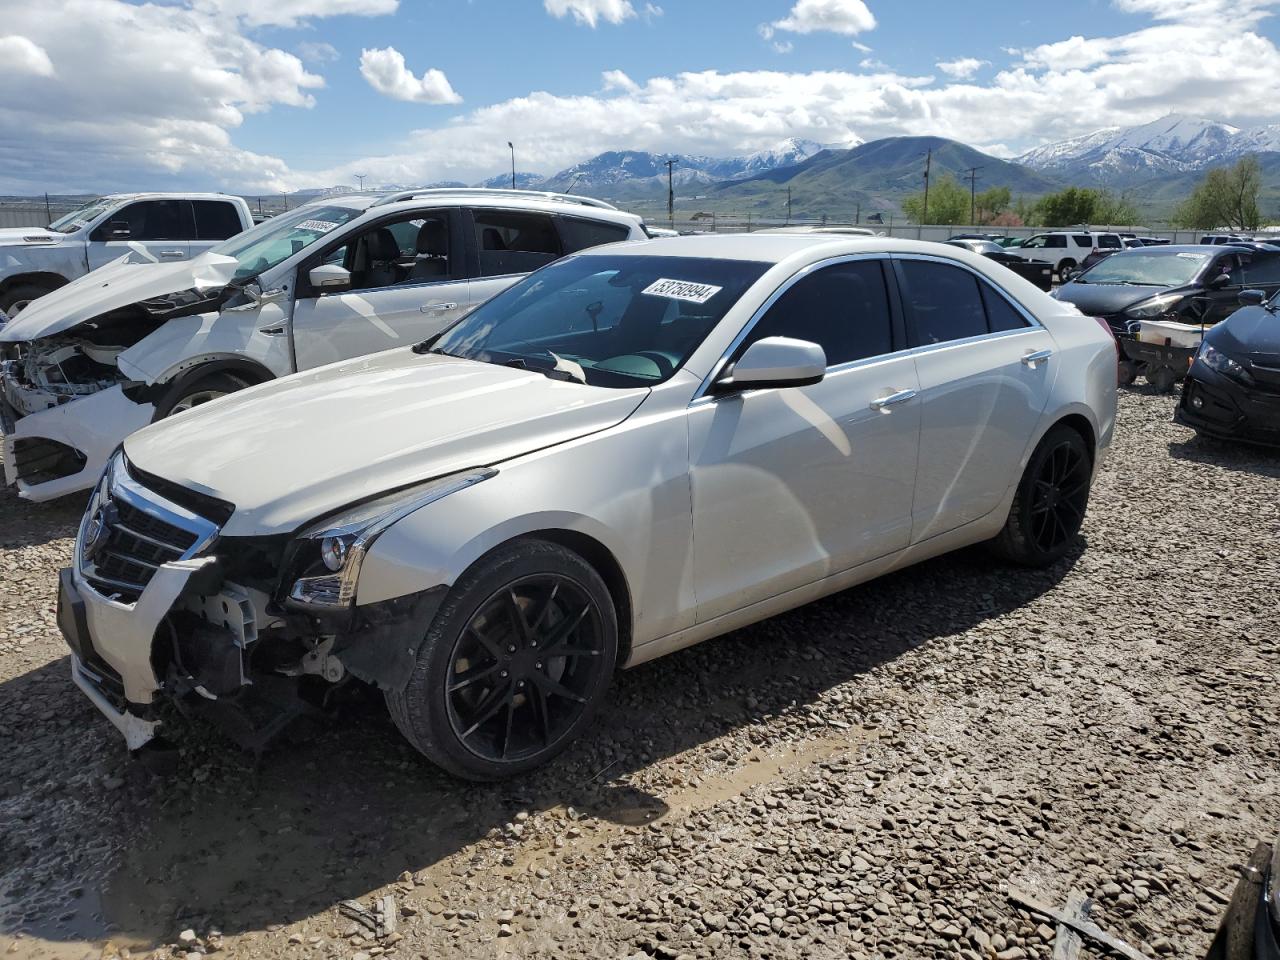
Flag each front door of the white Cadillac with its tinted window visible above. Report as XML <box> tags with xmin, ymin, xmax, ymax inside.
<box><xmin>689</xmin><ymin>259</ymin><xmax>920</xmax><ymax>622</ymax></box>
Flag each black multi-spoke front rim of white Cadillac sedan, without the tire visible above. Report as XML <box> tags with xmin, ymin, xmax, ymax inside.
<box><xmin>445</xmin><ymin>573</ymin><xmax>604</xmax><ymax>763</ymax></box>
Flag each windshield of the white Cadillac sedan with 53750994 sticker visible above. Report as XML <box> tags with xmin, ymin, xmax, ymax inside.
<box><xmin>431</xmin><ymin>255</ymin><xmax>771</xmax><ymax>387</ymax></box>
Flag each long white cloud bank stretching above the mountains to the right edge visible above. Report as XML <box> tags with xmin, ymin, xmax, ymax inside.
<box><xmin>299</xmin><ymin>0</ymin><xmax>1280</xmax><ymax>184</ymax></box>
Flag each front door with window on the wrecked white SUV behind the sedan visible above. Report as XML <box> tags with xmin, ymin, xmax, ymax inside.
<box><xmin>293</xmin><ymin>210</ymin><xmax>471</xmax><ymax>370</ymax></box>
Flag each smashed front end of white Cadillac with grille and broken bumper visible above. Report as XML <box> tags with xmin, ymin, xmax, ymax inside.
<box><xmin>58</xmin><ymin>456</ymin><xmax>443</xmax><ymax>750</ymax></box>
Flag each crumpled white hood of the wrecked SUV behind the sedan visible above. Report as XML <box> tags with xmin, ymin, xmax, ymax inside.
<box><xmin>0</xmin><ymin>252</ymin><xmax>239</xmax><ymax>343</ymax></box>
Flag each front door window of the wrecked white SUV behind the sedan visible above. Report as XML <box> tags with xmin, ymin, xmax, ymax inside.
<box><xmin>340</xmin><ymin>211</ymin><xmax>460</xmax><ymax>291</ymax></box>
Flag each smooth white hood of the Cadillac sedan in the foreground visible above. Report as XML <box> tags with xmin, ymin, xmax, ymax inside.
<box><xmin>124</xmin><ymin>348</ymin><xmax>649</xmax><ymax>536</ymax></box>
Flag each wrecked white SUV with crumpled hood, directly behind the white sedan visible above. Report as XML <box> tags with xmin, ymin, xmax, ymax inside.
<box><xmin>0</xmin><ymin>189</ymin><xmax>645</xmax><ymax>500</ymax></box>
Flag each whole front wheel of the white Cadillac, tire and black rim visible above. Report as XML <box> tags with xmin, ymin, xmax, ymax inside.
<box><xmin>385</xmin><ymin>540</ymin><xmax>618</xmax><ymax>781</ymax></box>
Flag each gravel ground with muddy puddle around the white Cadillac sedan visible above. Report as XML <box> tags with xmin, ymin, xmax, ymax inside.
<box><xmin>0</xmin><ymin>390</ymin><xmax>1280</xmax><ymax>960</ymax></box>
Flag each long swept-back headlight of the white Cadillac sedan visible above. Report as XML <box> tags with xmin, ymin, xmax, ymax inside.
<box><xmin>289</xmin><ymin>468</ymin><xmax>498</xmax><ymax>607</ymax></box>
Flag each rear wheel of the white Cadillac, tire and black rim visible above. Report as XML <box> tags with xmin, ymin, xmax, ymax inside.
<box><xmin>991</xmin><ymin>424</ymin><xmax>1093</xmax><ymax>567</ymax></box>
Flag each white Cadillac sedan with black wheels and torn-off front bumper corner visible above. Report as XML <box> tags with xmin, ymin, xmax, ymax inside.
<box><xmin>59</xmin><ymin>234</ymin><xmax>1116</xmax><ymax>780</ymax></box>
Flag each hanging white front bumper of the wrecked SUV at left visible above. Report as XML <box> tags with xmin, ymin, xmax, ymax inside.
<box><xmin>0</xmin><ymin>384</ymin><xmax>155</xmax><ymax>502</ymax></box>
